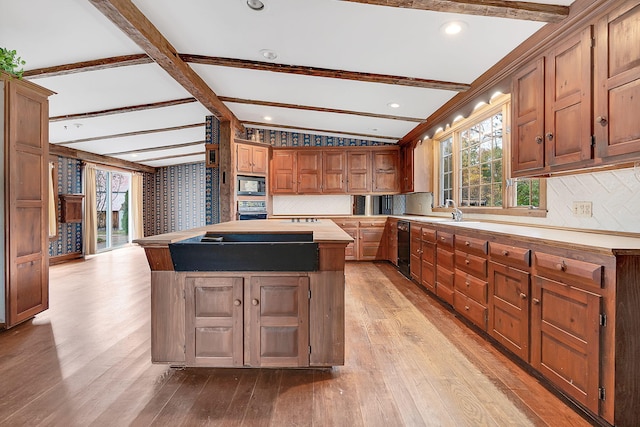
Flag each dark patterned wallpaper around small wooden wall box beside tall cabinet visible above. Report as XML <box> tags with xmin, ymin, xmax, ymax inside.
<box><xmin>49</xmin><ymin>156</ymin><xmax>82</xmax><ymax>257</ymax></box>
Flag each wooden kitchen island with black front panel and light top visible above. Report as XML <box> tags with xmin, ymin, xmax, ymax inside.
<box><xmin>135</xmin><ymin>220</ymin><xmax>353</xmax><ymax>367</ymax></box>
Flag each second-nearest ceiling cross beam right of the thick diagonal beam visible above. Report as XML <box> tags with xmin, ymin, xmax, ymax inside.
<box><xmin>180</xmin><ymin>54</ymin><xmax>470</xmax><ymax>92</ymax></box>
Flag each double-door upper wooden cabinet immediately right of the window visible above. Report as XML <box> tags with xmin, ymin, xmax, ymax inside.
<box><xmin>511</xmin><ymin>27</ymin><xmax>593</xmax><ymax>176</ymax></box>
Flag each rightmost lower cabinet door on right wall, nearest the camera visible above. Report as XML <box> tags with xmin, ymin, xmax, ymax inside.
<box><xmin>531</xmin><ymin>276</ymin><xmax>601</xmax><ymax>413</ymax></box>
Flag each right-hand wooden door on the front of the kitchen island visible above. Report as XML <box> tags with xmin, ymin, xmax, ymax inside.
<box><xmin>250</xmin><ymin>276</ymin><xmax>309</xmax><ymax>367</ymax></box>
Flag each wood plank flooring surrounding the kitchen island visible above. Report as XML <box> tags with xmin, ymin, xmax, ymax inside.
<box><xmin>0</xmin><ymin>247</ymin><xmax>588</xmax><ymax>427</ymax></box>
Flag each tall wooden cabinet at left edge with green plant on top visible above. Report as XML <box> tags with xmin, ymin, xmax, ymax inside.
<box><xmin>0</xmin><ymin>72</ymin><xmax>53</xmax><ymax>328</ymax></box>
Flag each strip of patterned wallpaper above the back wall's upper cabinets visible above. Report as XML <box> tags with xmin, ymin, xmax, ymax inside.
<box><xmin>246</xmin><ymin>128</ymin><xmax>386</xmax><ymax>147</ymax></box>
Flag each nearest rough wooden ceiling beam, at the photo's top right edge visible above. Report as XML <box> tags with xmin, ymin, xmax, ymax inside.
<box><xmin>342</xmin><ymin>0</ymin><xmax>569</xmax><ymax>22</ymax></box>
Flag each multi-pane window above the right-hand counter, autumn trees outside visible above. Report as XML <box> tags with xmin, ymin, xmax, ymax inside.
<box><xmin>434</xmin><ymin>95</ymin><xmax>545</xmax><ymax>211</ymax></box>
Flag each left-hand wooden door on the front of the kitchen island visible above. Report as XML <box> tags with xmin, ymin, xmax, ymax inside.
<box><xmin>185</xmin><ymin>277</ymin><xmax>243</xmax><ymax>367</ymax></box>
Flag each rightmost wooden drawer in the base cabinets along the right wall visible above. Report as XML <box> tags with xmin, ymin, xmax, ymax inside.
<box><xmin>534</xmin><ymin>252</ymin><xmax>604</xmax><ymax>289</ymax></box>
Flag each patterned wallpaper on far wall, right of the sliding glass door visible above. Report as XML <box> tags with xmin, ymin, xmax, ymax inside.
<box><xmin>143</xmin><ymin>162</ymin><xmax>206</xmax><ymax>236</ymax></box>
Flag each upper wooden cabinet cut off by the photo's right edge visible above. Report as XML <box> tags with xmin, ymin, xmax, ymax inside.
<box><xmin>594</xmin><ymin>1</ymin><xmax>640</xmax><ymax>163</ymax></box>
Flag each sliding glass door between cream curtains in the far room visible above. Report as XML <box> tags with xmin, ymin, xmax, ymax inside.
<box><xmin>96</xmin><ymin>169</ymin><xmax>131</xmax><ymax>251</ymax></box>
